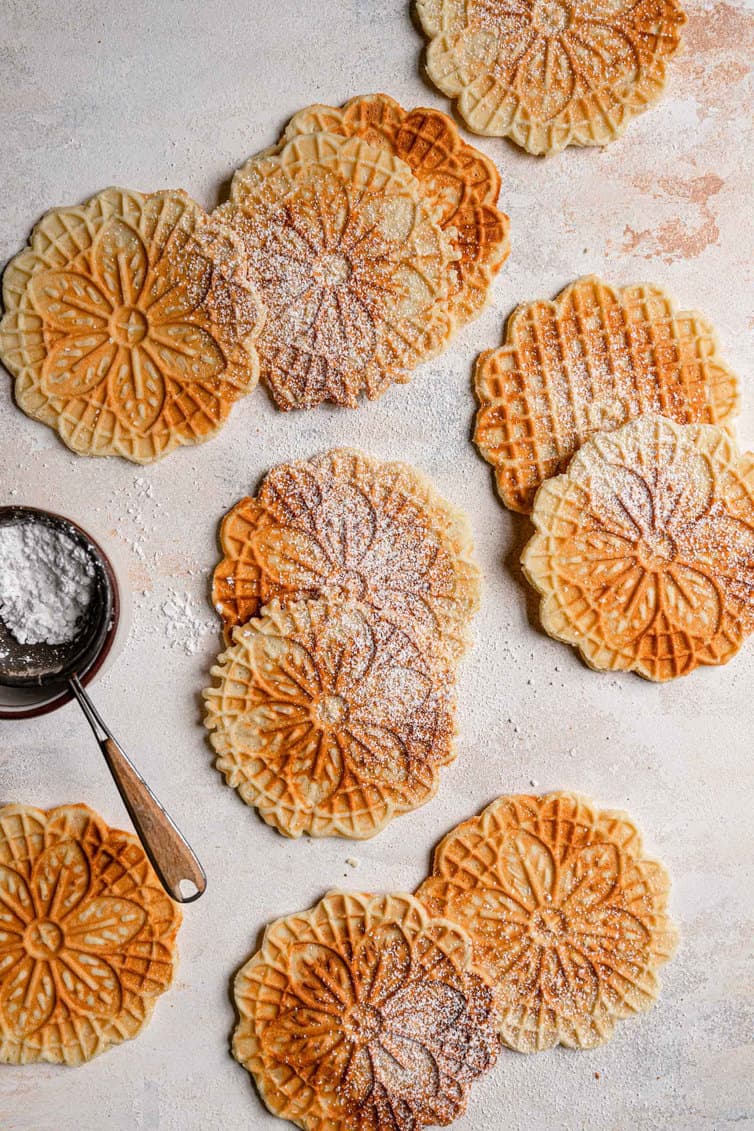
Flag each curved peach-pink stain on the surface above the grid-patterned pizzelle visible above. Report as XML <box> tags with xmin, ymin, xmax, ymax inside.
<box><xmin>622</xmin><ymin>173</ymin><xmax>725</xmax><ymax>264</ymax></box>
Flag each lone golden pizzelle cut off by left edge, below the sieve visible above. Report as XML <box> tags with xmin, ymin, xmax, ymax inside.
<box><xmin>0</xmin><ymin>805</ymin><xmax>181</xmax><ymax>1064</ymax></box>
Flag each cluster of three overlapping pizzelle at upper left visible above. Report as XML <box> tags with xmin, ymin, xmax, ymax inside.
<box><xmin>0</xmin><ymin>94</ymin><xmax>509</xmax><ymax>464</ymax></box>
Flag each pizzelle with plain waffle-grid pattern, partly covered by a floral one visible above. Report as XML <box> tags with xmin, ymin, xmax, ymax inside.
<box><xmin>474</xmin><ymin>276</ymin><xmax>738</xmax><ymax>513</ymax></box>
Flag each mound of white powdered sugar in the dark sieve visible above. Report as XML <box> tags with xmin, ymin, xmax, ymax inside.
<box><xmin>0</xmin><ymin>523</ymin><xmax>94</xmax><ymax>644</ymax></box>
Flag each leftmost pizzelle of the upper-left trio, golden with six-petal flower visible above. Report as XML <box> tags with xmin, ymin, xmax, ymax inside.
<box><xmin>0</xmin><ymin>188</ymin><xmax>263</xmax><ymax>464</ymax></box>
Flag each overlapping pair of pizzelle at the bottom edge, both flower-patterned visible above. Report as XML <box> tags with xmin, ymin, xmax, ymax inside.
<box><xmin>233</xmin><ymin>793</ymin><xmax>677</xmax><ymax>1131</ymax></box>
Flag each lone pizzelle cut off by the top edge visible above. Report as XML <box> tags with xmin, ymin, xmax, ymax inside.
<box><xmin>416</xmin><ymin>0</ymin><xmax>686</xmax><ymax>154</ymax></box>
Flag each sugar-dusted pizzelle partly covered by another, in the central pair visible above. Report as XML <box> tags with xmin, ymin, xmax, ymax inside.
<box><xmin>213</xmin><ymin>449</ymin><xmax>480</xmax><ymax>656</ymax></box>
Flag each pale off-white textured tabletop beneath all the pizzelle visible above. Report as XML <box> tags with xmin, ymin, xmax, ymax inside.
<box><xmin>0</xmin><ymin>0</ymin><xmax>754</xmax><ymax>1131</ymax></box>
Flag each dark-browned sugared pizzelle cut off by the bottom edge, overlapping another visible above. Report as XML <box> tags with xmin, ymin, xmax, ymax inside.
<box><xmin>233</xmin><ymin>892</ymin><xmax>497</xmax><ymax>1131</ymax></box>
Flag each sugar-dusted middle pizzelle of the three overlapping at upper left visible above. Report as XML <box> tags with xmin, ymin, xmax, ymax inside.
<box><xmin>215</xmin><ymin>133</ymin><xmax>457</xmax><ymax>408</ymax></box>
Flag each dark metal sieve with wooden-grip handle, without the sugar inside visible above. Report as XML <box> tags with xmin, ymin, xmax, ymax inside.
<box><xmin>0</xmin><ymin>507</ymin><xmax>207</xmax><ymax>904</ymax></box>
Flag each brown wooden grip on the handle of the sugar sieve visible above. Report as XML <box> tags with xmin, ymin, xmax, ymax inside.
<box><xmin>99</xmin><ymin>737</ymin><xmax>207</xmax><ymax>904</ymax></box>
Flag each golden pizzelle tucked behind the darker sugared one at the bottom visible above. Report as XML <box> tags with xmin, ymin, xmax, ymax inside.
<box><xmin>417</xmin><ymin>793</ymin><xmax>676</xmax><ymax>1052</ymax></box>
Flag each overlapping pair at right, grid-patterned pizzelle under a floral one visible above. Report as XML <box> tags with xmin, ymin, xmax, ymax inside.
<box><xmin>475</xmin><ymin>277</ymin><xmax>754</xmax><ymax>681</ymax></box>
